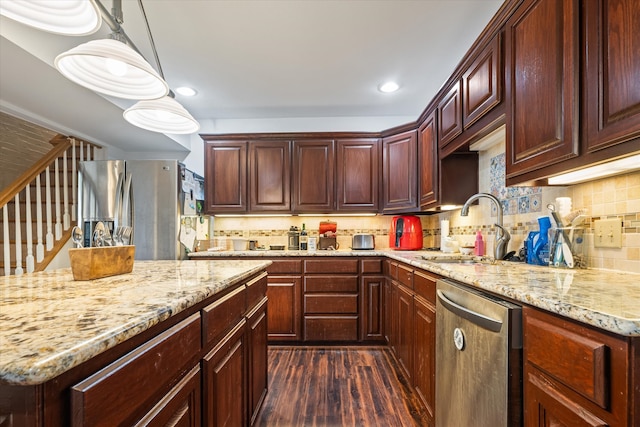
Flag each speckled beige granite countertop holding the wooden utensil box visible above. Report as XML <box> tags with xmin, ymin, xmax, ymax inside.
<box><xmin>0</xmin><ymin>260</ymin><xmax>270</xmax><ymax>385</ymax></box>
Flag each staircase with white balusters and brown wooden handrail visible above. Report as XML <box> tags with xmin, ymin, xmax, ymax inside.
<box><xmin>0</xmin><ymin>135</ymin><xmax>100</xmax><ymax>276</ymax></box>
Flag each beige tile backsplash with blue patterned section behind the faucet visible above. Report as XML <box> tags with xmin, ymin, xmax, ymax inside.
<box><xmin>211</xmin><ymin>144</ymin><xmax>640</xmax><ymax>273</ymax></box>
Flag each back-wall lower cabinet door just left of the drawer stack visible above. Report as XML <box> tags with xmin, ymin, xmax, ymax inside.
<box><xmin>267</xmin><ymin>276</ymin><xmax>302</xmax><ymax>341</ymax></box>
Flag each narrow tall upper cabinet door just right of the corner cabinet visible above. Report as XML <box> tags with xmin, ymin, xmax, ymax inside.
<box><xmin>418</xmin><ymin>110</ymin><xmax>439</xmax><ymax>209</ymax></box>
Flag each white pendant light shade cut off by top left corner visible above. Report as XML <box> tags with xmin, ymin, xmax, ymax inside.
<box><xmin>0</xmin><ymin>0</ymin><xmax>102</xmax><ymax>36</ymax></box>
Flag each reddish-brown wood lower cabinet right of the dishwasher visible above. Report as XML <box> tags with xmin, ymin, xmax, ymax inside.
<box><xmin>522</xmin><ymin>307</ymin><xmax>640</xmax><ymax>426</ymax></box>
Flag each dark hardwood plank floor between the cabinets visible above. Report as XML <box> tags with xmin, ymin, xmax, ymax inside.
<box><xmin>255</xmin><ymin>346</ymin><xmax>427</xmax><ymax>427</ymax></box>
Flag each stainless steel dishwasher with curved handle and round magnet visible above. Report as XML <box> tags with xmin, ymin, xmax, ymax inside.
<box><xmin>435</xmin><ymin>279</ymin><xmax>522</xmax><ymax>427</ymax></box>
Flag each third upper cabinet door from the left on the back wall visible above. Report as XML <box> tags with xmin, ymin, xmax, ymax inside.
<box><xmin>293</xmin><ymin>140</ymin><xmax>335</xmax><ymax>212</ymax></box>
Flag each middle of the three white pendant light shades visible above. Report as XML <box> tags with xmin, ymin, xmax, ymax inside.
<box><xmin>54</xmin><ymin>39</ymin><xmax>169</xmax><ymax>100</ymax></box>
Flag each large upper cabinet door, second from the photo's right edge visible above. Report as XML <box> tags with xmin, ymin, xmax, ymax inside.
<box><xmin>505</xmin><ymin>0</ymin><xmax>580</xmax><ymax>179</ymax></box>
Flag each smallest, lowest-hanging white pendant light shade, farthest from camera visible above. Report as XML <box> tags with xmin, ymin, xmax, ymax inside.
<box><xmin>123</xmin><ymin>96</ymin><xmax>200</xmax><ymax>134</ymax></box>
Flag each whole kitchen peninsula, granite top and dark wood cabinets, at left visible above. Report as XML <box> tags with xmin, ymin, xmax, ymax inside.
<box><xmin>0</xmin><ymin>260</ymin><xmax>271</xmax><ymax>426</ymax></box>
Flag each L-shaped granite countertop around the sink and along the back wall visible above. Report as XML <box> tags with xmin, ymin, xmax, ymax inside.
<box><xmin>190</xmin><ymin>250</ymin><xmax>640</xmax><ymax>337</ymax></box>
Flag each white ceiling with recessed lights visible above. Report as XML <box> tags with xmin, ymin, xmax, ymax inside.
<box><xmin>0</xmin><ymin>0</ymin><xmax>502</xmax><ymax>152</ymax></box>
